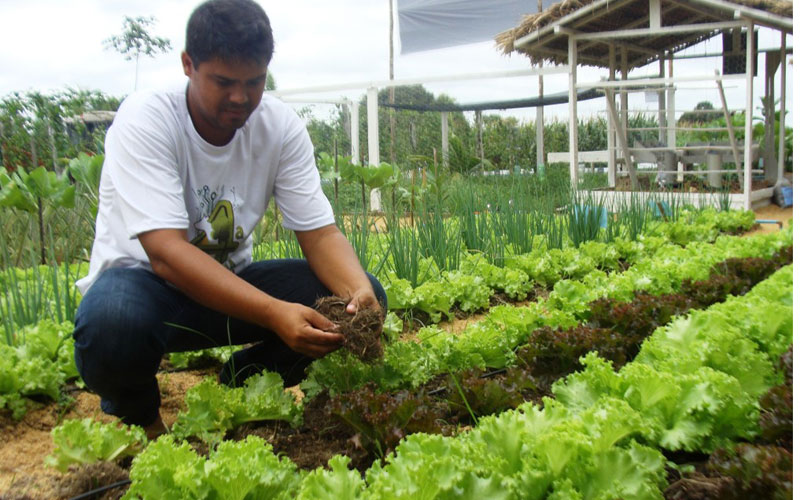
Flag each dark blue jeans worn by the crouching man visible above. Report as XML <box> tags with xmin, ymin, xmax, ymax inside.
<box><xmin>73</xmin><ymin>259</ymin><xmax>386</xmax><ymax>426</ymax></box>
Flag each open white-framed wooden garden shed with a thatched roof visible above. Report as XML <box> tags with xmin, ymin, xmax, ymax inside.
<box><xmin>495</xmin><ymin>0</ymin><xmax>792</xmax><ymax>209</ymax></box>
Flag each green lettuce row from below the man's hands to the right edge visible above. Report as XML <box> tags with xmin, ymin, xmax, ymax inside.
<box><xmin>301</xmin><ymin>221</ymin><xmax>792</xmax><ymax>396</ymax></box>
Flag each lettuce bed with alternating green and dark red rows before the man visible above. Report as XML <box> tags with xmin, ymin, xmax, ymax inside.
<box><xmin>0</xmin><ymin>205</ymin><xmax>792</xmax><ymax>499</ymax></box>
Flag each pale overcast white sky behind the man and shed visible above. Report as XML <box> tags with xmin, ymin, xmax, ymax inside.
<box><xmin>0</xmin><ymin>0</ymin><xmax>794</xmax><ymax>125</ymax></box>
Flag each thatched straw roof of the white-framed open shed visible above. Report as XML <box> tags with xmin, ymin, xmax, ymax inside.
<box><xmin>495</xmin><ymin>0</ymin><xmax>792</xmax><ymax>68</ymax></box>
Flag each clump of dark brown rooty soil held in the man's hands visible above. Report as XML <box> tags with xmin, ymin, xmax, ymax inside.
<box><xmin>314</xmin><ymin>296</ymin><xmax>383</xmax><ymax>361</ymax></box>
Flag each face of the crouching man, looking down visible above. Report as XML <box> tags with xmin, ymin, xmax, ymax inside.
<box><xmin>181</xmin><ymin>52</ymin><xmax>267</xmax><ymax>146</ymax></box>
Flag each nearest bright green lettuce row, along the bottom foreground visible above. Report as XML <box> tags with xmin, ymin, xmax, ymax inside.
<box><xmin>51</xmin><ymin>258</ymin><xmax>793</xmax><ymax>500</ymax></box>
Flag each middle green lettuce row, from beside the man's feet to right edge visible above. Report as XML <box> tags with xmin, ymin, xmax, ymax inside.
<box><xmin>164</xmin><ymin>221</ymin><xmax>791</xmax><ymax>442</ymax></box>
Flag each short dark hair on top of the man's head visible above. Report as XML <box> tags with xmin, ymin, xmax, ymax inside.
<box><xmin>186</xmin><ymin>0</ymin><xmax>275</xmax><ymax>66</ymax></box>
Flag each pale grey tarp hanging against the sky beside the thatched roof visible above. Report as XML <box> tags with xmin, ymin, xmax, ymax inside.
<box><xmin>397</xmin><ymin>0</ymin><xmax>558</xmax><ymax>54</ymax></box>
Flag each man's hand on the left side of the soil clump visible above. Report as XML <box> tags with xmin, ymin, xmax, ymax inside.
<box><xmin>269</xmin><ymin>302</ymin><xmax>344</xmax><ymax>358</ymax></box>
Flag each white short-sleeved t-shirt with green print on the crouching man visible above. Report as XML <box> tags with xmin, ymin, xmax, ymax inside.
<box><xmin>76</xmin><ymin>88</ymin><xmax>334</xmax><ymax>293</ymax></box>
